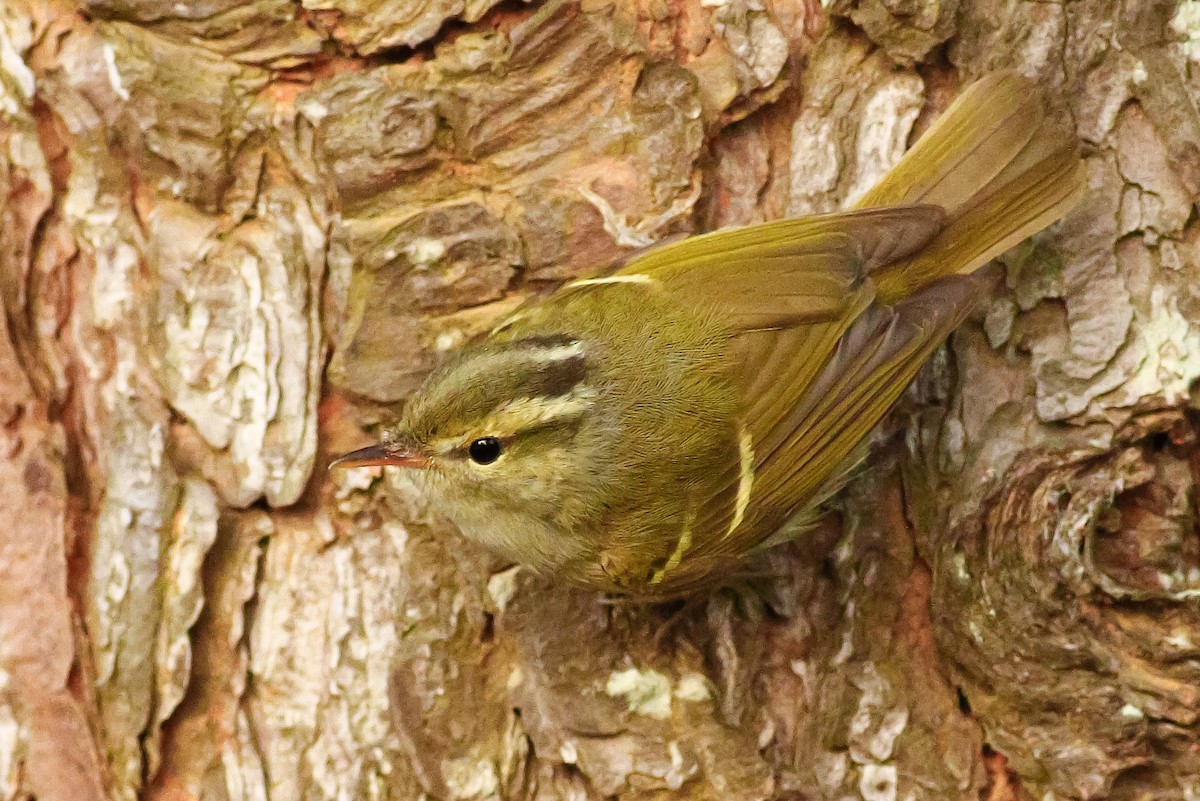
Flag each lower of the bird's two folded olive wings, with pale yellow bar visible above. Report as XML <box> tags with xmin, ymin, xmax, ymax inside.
<box><xmin>694</xmin><ymin>271</ymin><xmax>996</xmax><ymax>556</ymax></box>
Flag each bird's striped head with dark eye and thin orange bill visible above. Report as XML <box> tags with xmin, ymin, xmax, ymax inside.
<box><xmin>332</xmin><ymin>336</ymin><xmax>619</xmax><ymax>570</ymax></box>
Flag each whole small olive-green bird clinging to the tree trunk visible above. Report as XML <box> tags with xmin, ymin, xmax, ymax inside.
<box><xmin>337</xmin><ymin>73</ymin><xmax>1084</xmax><ymax>600</ymax></box>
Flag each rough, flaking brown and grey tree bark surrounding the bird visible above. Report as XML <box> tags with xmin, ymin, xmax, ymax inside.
<box><xmin>0</xmin><ymin>0</ymin><xmax>1200</xmax><ymax>801</ymax></box>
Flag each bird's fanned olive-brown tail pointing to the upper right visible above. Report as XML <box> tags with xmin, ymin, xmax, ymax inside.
<box><xmin>856</xmin><ymin>72</ymin><xmax>1084</xmax><ymax>302</ymax></box>
